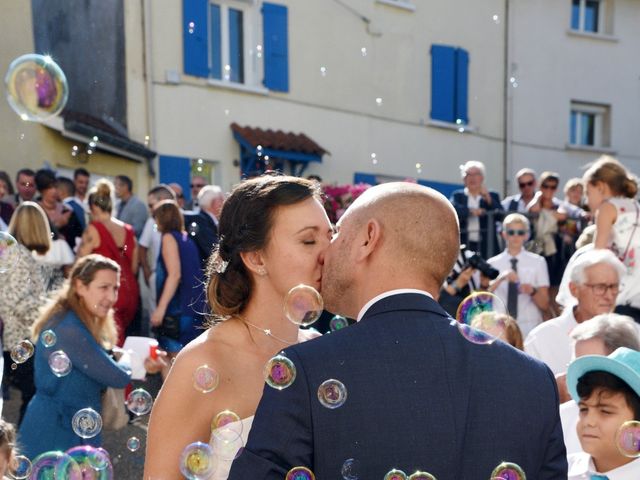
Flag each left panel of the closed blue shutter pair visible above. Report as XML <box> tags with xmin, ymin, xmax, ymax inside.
<box><xmin>431</xmin><ymin>45</ymin><xmax>456</xmax><ymax>123</ymax></box>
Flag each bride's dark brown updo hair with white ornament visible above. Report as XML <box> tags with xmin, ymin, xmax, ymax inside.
<box><xmin>207</xmin><ymin>175</ymin><xmax>320</xmax><ymax>321</ymax></box>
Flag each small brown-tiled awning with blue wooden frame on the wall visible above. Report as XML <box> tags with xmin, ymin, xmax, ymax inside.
<box><xmin>231</xmin><ymin>123</ymin><xmax>329</xmax><ymax>176</ymax></box>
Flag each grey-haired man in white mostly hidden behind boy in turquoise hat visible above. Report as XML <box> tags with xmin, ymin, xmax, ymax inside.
<box><xmin>556</xmin><ymin>313</ymin><xmax>640</xmax><ymax>456</ymax></box>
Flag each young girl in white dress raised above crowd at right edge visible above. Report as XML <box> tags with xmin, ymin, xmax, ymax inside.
<box><xmin>582</xmin><ymin>155</ymin><xmax>640</xmax><ymax>322</ymax></box>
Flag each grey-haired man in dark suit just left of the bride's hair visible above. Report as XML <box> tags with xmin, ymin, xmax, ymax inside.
<box><xmin>184</xmin><ymin>185</ymin><xmax>225</xmax><ymax>268</ymax></box>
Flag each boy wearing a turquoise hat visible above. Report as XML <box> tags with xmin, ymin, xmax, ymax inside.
<box><xmin>567</xmin><ymin>347</ymin><xmax>640</xmax><ymax>480</ymax></box>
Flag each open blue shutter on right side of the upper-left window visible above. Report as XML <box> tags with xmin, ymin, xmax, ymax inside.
<box><xmin>262</xmin><ymin>2</ymin><xmax>289</xmax><ymax>92</ymax></box>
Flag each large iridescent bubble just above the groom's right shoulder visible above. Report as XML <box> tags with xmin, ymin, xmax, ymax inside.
<box><xmin>456</xmin><ymin>292</ymin><xmax>507</xmax><ymax>345</ymax></box>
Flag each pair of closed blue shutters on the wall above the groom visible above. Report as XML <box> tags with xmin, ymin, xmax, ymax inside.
<box><xmin>431</xmin><ymin>45</ymin><xmax>469</xmax><ymax>125</ymax></box>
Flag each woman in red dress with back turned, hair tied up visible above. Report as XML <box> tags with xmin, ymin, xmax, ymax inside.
<box><xmin>78</xmin><ymin>179</ymin><xmax>140</xmax><ymax>346</ymax></box>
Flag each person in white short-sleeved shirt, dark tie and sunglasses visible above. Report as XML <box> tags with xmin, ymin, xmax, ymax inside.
<box><xmin>488</xmin><ymin>213</ymin><xmax>549</xmax><ymax>337</ymax></box>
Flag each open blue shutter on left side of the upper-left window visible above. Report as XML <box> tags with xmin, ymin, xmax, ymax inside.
<box><xmin>182</xmin><ymin>0</ymin><xmax>209</xmax><ymax>77</ymax></box>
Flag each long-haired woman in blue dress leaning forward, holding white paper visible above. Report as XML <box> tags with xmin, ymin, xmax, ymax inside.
<box><xmin>19</xmin><ymin>255</ymin><xmax>160</xmax><ymax>458</ymax></box>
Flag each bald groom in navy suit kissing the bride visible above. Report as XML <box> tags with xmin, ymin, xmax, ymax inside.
<box><xmin>229</xmin><ymin>183</ymin><xmax>567</xmax><ymax>480</ymax></box>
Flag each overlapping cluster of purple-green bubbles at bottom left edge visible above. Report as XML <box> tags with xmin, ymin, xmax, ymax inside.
<box><xmin>28</xmin><ymin>445</ymin><xmax>113</xmax><ymax>480</ymax></box>
